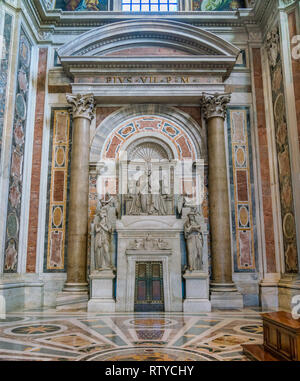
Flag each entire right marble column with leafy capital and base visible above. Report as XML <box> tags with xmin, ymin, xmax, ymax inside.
<box><xmin>201</xmin><ymin>93</ymin><xmax>243</xmax><ymax>308</ymax></box>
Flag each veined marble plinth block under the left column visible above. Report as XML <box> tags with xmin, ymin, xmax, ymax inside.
<box><xmin>56</xmin><ymin>291</ymin><xmax>88</xmax><ymax>311</ymax></box>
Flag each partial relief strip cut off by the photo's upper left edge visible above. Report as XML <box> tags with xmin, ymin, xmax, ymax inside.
<box><xmin>0</xmin><ymin>13</ymin><xmax>12</xmax><ymax>163</ymax></box>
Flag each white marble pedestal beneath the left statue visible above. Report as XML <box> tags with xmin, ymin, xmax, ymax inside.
<box><xmin>88</xmin><ymin>270</ymin><xmax>116</xmax><ymax>312</ymax></box>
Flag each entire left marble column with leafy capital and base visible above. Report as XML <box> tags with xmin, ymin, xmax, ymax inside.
<box><xmin>57</xmin><ymin>94</ymin><xmax>94</xmax><ymax>310</ymax></box>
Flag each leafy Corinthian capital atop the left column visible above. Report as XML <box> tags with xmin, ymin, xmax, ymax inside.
<box><xmin>66</xmin><ymin>94</ymin><xmax>95</xmax><ymax>120</ymax></box>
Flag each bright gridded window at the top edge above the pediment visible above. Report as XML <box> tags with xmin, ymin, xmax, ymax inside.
<box><xmin>122</xmin><ymin>0</ymin><xmax>178</xmax><ymax>12</ymax></box>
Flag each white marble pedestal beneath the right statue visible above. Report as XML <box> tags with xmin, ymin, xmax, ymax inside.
<box><xmin>183</xmin><ymin>271</ymin><xmax>211</xmax><ymax>312</ymax></box>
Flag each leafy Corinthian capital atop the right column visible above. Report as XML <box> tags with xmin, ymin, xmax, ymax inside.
<box><xmin>201</xmin><ymin>93</ymin><xmax>231</xmax><ymax>119</ymax></box>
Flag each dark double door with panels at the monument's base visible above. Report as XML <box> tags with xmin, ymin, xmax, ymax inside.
<box><xmin>134</xmin><ymin>262</ymin><xmax>164</xmax><ymax>312</ymax></box>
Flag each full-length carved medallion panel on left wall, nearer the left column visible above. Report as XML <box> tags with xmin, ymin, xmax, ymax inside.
<box><xmin>3</xmin><ymin>28</ymin><xmax>32</xmax><ymax>273</ymax></box>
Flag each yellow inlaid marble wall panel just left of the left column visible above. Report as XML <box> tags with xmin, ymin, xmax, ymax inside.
<box><xmin>44</xmin><ymin>109</ymin><xmax>71</xmax><ymax>272</ymax></box>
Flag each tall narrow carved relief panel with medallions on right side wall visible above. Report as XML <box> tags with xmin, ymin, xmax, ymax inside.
<box><xmin>266</xmin><ymin>28</ymin><xmax>299</xmax><ymax>273</ymax></box>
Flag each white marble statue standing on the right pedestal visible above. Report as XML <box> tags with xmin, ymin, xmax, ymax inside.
<box><xmin>184</xmin><ymin>212</ymin><xmax>203</xmax><ymax>271</ymax></box>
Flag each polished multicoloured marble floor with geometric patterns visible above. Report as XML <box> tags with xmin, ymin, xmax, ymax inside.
<box><xmin>0</xmin><ymin>309</ymin><xmax>262</xmax><ymax>361</ymax></box>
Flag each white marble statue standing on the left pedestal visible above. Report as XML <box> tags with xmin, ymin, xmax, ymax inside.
<box><xmin>94</xmin><ymin>208</ymin><xmax>113</xmax><ymax>270</ymax></box>
